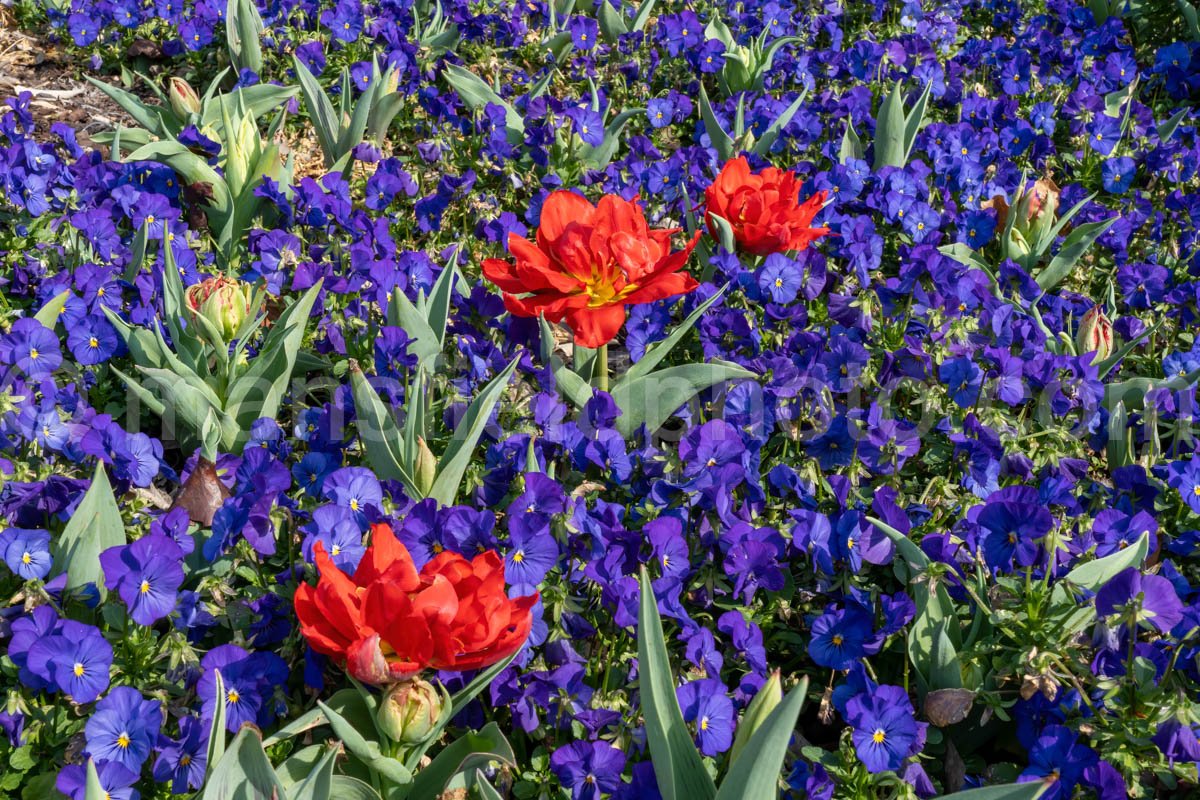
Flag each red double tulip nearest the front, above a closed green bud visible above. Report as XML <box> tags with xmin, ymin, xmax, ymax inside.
<box><xmin>295</xmin><ymin>524</ymin><xmax>538</xmax><ymax>685</ymax></box>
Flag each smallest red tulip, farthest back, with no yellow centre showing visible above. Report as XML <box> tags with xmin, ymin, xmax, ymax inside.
<box><xmin>704</xmin><ymin>156</ymin><xmax>829</xmax><ymax>255</ymax></box>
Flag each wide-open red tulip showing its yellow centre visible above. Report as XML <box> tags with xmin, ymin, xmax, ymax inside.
<box><xmin>484</xmin><ymin>192</ymin><xmax>700</xmax><ymax>348</ymax></box>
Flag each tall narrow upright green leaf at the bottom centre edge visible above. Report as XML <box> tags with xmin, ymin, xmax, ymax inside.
<box><xmin>637</xmin><ymin>566</ymin><xmax>716</xmax><ymax>800</ymax></box>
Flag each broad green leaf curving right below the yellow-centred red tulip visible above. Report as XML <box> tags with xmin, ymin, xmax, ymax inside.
<box><xmin>612</xmin><ymin>359</ymin><xmax>757</xmax><ymax>439</ymax></box>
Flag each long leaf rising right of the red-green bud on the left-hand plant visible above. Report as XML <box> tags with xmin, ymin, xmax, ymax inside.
<box><xmin>224</xmin><ymin>278</ymin><xmax>324</xmax><ymax>446</ymax></box>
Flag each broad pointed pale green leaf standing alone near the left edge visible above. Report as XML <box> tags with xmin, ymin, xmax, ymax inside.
<box><xmin>54</xmin><ymin>462</ymin><xmax>125</xmax><ymax>600</ymax></box>
